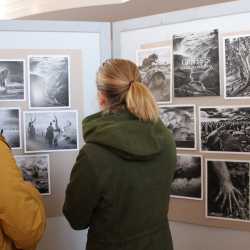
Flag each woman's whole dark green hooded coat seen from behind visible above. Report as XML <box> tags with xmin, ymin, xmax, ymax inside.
<box><xmin>63</xmin><ymin>111</ymin><xmax>176</xmax><ymax>250</ymax></box>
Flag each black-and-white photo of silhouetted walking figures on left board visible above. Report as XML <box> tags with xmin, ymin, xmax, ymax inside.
<box><xmin>24</xmin><ymin>110</ymin><xmax>78</xmax><ymax>153</ymax></box>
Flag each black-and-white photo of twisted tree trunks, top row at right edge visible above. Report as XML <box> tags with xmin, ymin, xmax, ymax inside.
<box><xmin>224</xmin><ymin>35</ymin><xmax>250</xmax><ymax>99</ymax></box>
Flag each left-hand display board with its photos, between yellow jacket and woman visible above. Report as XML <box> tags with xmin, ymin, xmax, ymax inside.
<box><xmin>0</xmin><ymin>21</ymin><xmax>110</xmax><ymax>217</ymax></box>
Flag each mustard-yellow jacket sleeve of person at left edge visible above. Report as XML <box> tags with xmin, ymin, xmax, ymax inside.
<box><xmin>0</xmin><ymin>141</ymin><xmax>46</xmax><ymax>250</ymax></box>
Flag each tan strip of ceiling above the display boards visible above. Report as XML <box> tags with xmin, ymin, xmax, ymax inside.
<box><xmin>20</xmin><ymin>0</ymin><xmax>236</xmax><ymax>21</ymax></box>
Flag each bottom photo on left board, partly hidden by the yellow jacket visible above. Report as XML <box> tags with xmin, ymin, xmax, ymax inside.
<box><xmin>15</xmin><ymin>155</ymin><xmax>51</xmax><ymax>195</ymax></box>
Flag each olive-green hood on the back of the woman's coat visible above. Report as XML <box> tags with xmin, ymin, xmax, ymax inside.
<box><xmin>83</xmin><ymin>110</ymin><xmax>166</xmax><ymax>160</ymax></box>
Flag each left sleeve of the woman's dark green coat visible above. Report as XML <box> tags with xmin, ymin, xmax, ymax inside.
<box><xmin>63</xmin><ymin>149</ymin><xmax>100</xmax><ymax>230</ymax></box>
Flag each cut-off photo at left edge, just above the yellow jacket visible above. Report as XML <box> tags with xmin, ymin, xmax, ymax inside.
<box><xmin>0</xmin><ymin>108</ymin><xmax>21</xmax><ymax>149</ymax></box>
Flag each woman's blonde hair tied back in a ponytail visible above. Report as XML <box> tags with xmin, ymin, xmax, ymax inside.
<box><xmin>97</xmin><ymin>59</ymin><xmax>159</xmax><ymax>122</ymax></box>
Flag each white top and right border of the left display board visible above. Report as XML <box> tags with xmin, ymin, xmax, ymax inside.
<box><xmin>0</xmin><ymin>21</ymin><xmax>111</xmax><ymax>115</ymax></box>
